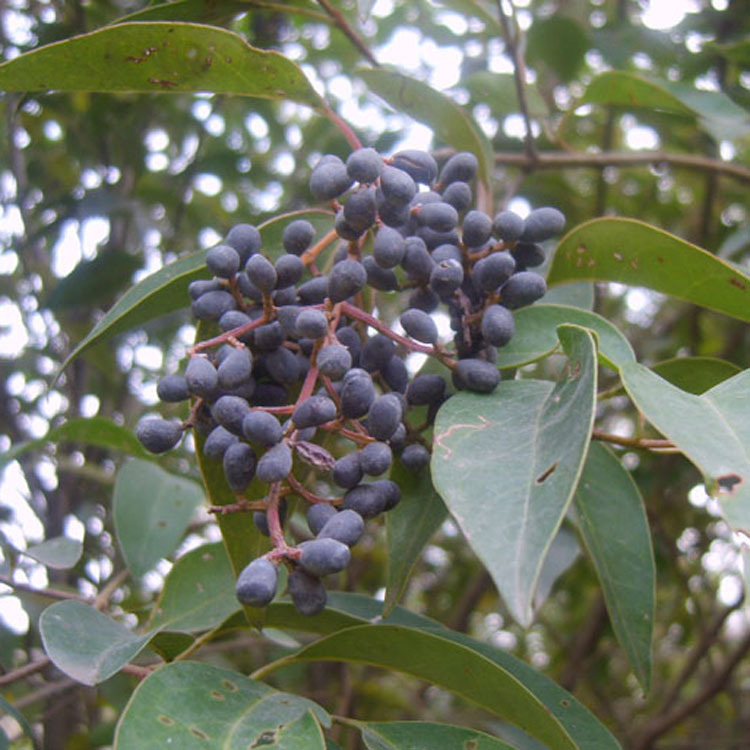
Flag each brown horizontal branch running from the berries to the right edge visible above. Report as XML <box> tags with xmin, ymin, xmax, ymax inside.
<box><xmin>495</xmin><ymin>151</ymin><xmax>750</xmax><ymax>183</ymax></box>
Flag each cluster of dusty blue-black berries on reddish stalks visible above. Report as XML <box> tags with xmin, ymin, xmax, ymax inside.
<box><xmin>137</xmin><ymin>148</ymin><xmax>565</xmax><ymax>614</ymax></box>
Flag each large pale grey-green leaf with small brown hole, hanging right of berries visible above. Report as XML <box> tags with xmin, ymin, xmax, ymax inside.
<box><xmin>432</xmin><ymin>326</ymin><xmax>596</xmax><ymax>626</ymax></box>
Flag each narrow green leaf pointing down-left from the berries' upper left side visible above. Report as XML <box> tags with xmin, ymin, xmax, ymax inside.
<box><xmin>58</xmin><ymin>250</ymin><xmax>211</xmax><ymax>377</ymax></box>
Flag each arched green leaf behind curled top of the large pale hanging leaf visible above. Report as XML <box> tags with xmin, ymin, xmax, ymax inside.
<box><xmin>497</xmin><ymin>304</ymin><xmax>635</xmax><ymax>370</ymax></box>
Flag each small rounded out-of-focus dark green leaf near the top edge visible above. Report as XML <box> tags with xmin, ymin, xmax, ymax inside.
<box><xmin>526</xmin><ymin>13</ymin><xmax>591</xmax><ymax>83</ymax></box>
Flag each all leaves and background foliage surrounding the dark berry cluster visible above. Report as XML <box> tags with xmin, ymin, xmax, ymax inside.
<box><xmin>0</xmin><ymin>0</ymin><xmax>750</xmax><ymax>750</ymax></box>
